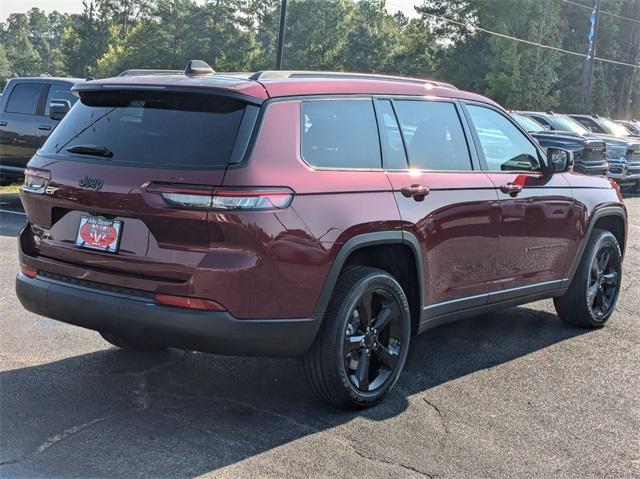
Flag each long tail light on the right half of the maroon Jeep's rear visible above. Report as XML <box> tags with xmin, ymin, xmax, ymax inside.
<box><xmin>146</xmin><ymin>183</ymin><xmax>294</xmax><ymax>211</ymax></box>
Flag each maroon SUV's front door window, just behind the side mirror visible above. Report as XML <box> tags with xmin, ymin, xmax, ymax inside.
<box><xmin>467</xmin><ymin>105</ymin><xmax>540</xmax><ymax>171</ymax></box>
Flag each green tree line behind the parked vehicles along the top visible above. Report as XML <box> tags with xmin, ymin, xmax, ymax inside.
<box><xmin>0</xmin><ymin>0</ymin><xmax>640</xmax><ymax>118</ymax></box>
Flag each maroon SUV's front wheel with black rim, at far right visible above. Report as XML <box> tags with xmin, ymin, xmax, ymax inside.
<box><xmin>553</xmin><ymin>228</ymin><xmax>622</xmax><ymax>328</ymax></box>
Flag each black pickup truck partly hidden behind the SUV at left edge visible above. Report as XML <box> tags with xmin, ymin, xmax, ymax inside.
<box><xmin>0</xmin><ymin>77</ymin><xmax>83</xmax><ymax>182</ymax></box>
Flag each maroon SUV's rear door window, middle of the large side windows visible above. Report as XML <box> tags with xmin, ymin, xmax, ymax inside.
<box><xmin>394</xmin><ymin>100</ymin><xmax>472</xmax><ymax>171</ymax></box>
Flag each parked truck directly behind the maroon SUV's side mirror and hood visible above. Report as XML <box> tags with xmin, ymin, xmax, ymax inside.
<box><xmin>511</xmin><ymin>112</ymin><xmax>609</xmax><ymax>176</ymax></box>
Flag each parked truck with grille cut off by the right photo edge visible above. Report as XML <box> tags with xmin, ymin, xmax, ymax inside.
<box><xmin>519</xmin><ymin>111</ymin><xmax>640</xmax><ymax>186</ymax></box>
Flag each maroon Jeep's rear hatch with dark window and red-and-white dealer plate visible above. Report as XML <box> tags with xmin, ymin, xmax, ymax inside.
<box><xmin>22</xmin><ymin>83</ymin><xmax>258</xmax><ymax>284</ymax></box>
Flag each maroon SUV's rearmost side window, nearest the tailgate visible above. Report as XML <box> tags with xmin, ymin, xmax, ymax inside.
<box><xmin>302</xmin><ymin>99</ymin><xmax>382</xmax><ymax>168</ymax></box>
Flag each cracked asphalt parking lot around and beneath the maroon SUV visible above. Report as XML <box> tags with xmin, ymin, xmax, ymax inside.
<box><xmin>0</xmin><ymin>195</ymin><xmax>640</xmax><ymax>478</ymax></box>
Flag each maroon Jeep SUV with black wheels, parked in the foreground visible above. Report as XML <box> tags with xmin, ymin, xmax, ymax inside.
<box><xmin>16</xmin><ymin>62</ymin><xmax>627</xmax><ymax>407</ymax></box>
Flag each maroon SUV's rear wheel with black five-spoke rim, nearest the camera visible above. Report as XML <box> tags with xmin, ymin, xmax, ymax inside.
<box><xmin>302</xmin><ymin>266</ymin><xmax>411</xmax><ymax>409</ymax></box>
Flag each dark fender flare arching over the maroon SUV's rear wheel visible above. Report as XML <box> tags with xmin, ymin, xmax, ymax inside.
<box><xmin>314</xmin><ymin>230</ymin><xmax>424</xmax><ymax>315</ymax></box>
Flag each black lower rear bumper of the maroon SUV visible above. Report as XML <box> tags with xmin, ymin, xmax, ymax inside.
<box><xmin>16</xmin><ymin>273</ymin><xmax>321</xmax><ymax>357</ymax></box>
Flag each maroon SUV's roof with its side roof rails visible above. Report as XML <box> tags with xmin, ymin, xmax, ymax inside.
<box><xmin>74</xmin><ymin>72</ymin><xmax>496</xmax><ymax>105</ymax></box>
